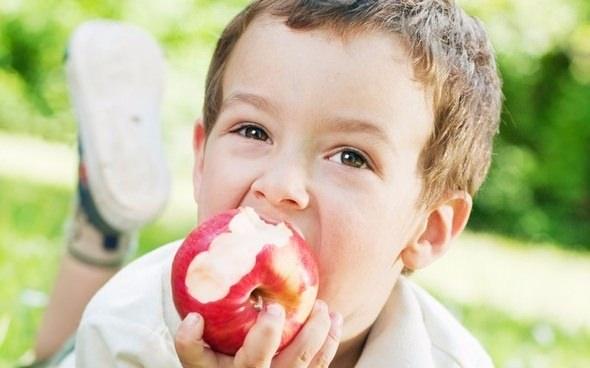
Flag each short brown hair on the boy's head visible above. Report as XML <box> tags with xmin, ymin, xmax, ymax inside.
<box><xmin>203</xmin><ymin>0</ymin><xmax>502</xmax><ymax>206</ymax></box>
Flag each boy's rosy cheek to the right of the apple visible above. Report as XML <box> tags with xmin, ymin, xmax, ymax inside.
<box><xmin>318</xmin><ymin>182</ymin><xmax>420</xmax><ymax>302</ymax></box>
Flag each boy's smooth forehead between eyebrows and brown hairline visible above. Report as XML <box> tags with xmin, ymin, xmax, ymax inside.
<box><xmin>223</xmin><ymin>16</ymin><xmax>433</xmax><ymax>150</ymax></box>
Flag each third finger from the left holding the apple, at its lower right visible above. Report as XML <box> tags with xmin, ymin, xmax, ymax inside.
<box><xmin>275</xmin><ymin>300</ymin><xmax>331</xmax><ymax>368</ymax></box>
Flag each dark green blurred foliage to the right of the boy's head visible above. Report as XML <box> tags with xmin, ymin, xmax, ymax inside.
<box><xmin>464</xmin><ymin>0</ymin><xmax>590</xmax><ymax>250</ymax></box>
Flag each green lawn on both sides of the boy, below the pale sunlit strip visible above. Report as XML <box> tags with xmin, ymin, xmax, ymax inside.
<box><xmin>0</xmin><ymin>177</ymin><xmax>590</xmax><ymax>368</ymax></box>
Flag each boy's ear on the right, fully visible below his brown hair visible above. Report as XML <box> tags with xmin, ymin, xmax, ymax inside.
<box><xmin>400</xmin><ymin>191</ymin><xmax>473</xmax><ymax>270</ymax></box>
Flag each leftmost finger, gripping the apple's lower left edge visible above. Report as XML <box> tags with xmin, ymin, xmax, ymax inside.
<box><xmin>174</xmin><ymin>313</ymin><xmax>217</xmax><ymax>368</ymax></box>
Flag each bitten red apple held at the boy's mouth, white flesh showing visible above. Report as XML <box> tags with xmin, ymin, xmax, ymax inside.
<box><xmin>171</xmin><ymin>207</ymin><xmax>318</xmax><ymax>355</ymax></box>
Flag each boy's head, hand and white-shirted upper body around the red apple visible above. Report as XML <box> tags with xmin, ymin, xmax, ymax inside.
<box><xmin>62</xmin><ymin>0</ymin><xmax>501</xmax><ymax>368</ymax></box>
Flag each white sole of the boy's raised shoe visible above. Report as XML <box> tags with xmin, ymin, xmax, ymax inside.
<box><xmin>66</xmin><ymin>21</ymin><xmax>170</xmax><ymax>231</ymax></box>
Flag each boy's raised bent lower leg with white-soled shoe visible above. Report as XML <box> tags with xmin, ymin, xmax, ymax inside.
<box><xmin>35</xmin><ymin>21</ymin><xmax>169</xmax><ymax>360</ymax></box>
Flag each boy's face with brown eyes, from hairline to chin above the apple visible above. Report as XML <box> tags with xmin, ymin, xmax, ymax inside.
<box><xmin>195</xmin><ymin>17</ymin><xmax>433</xmax><ymax>340</ymax></box>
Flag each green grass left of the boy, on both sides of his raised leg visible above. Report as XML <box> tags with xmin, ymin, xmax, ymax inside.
<box><xmin>0</xmin><ymin>177</ymin><xmax>190</xmax><ymax>367</ymax></box>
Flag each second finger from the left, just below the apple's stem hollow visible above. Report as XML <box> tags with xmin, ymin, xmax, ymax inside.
<box><xmin>234</xmin><ymin>304</ymin><xmax>285</xmax><ymax>368</ymax></box>
